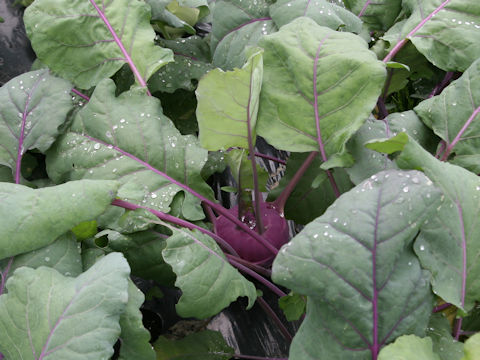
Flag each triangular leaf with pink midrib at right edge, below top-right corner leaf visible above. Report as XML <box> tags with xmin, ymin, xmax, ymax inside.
<box><xmin>414</xmin><ymin>58</ymin><xmax>480</xmax><ymax>173</ymax></box>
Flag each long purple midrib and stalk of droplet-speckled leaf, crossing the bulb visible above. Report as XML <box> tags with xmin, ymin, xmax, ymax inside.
<box><xmin>82</xmin><ymin>134</ymin><xmax>278</xmax><ymax>256</ymax></box>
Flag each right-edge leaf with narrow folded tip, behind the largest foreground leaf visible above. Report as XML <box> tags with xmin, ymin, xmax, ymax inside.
<box><xmin>397</xmin><ymin>139</ymin><xmax>480</xmax><ymax>311</ymax></box>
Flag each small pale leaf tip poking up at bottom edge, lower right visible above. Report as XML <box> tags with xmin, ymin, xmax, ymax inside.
<box><xmin>378</xmin><ymin>335</ymin><xmax>440</xmax><ymax>360</ymax></box>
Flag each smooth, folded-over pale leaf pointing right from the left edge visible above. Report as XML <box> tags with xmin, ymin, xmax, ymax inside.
<box><xmin>0</xmin><ymin>180</ymin><xmax>118</xmax><ymax>259</ymax></box>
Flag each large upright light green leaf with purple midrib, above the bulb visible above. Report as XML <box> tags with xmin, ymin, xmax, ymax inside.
<box><xmin>257</xmin><ymin>17</ymin><xmax>385</xmax><ymax>157</ymax></box>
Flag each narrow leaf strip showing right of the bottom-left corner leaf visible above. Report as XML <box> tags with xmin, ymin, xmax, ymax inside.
<box><xmin>119</xmin><ymin>279</ymin><xmax>156</xmax><ymax>360</ymax></box>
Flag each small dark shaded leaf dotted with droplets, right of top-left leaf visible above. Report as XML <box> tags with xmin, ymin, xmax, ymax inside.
<box><xmin>148</xmin><ymin>36</ymin><xmax>213</xmax><ymax>93</ymax></box>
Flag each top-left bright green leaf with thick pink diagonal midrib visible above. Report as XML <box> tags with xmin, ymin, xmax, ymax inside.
<box><xmin>24</xmin><ymin>0</ymin><xmax>173</xmax><ymax>89</ymax></box>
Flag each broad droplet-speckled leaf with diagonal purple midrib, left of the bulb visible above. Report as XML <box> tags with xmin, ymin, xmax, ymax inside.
<box><xmin>47</xmin><ymin>80</ymin><xmax>211</xmax><ymax>220</ymax></box>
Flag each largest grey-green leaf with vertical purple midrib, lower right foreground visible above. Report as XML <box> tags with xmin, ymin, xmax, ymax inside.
<box><xmin>273</xmin><ymin>170</ymin><xmax>441</xmax><ymax>360</ymax></box>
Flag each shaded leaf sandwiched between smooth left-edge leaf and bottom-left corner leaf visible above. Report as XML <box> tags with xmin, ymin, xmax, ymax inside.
<box><xmin>0</xmin><ymin>232</ymin><xmax>83</xmax><ymax>294</ymax></box>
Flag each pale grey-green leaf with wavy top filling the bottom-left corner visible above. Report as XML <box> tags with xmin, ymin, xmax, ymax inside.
<box><xmin>0</xmin><ymin>253</ymin><xmax>130</xmax><ymax>360</ymax></box>
